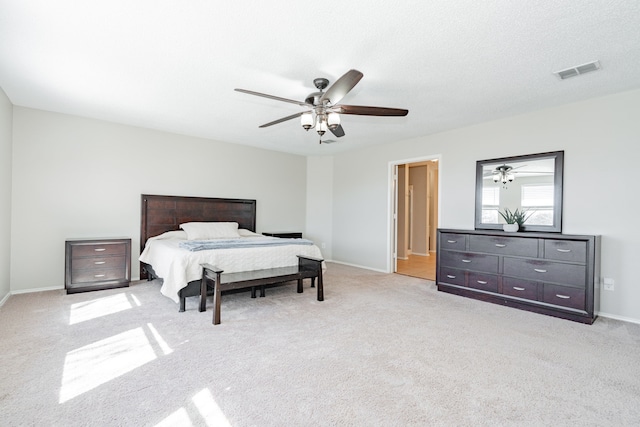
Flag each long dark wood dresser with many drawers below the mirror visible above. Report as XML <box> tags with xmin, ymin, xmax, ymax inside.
<box><xmin>436</xmin><ymin>229</ymin><xmax>600</xmax><ymax>324</ymax></box>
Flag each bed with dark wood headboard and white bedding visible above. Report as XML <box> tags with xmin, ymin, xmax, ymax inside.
<box><xmin>140</xmin><ymin>194</ymin><xmax>322</xmax><ymax>311</ymax></box>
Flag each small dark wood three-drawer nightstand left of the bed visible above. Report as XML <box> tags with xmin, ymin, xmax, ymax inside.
<box><xmin>64</xmin><ymin>238</ymin><xmax>131</xmax><ymax>294</ymax></box>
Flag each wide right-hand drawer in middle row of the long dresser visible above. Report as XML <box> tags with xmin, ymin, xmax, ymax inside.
<box><xmin>503</xmin><ymin>257</ymin><xmax>587</xmax><ymax>289</ymax></box>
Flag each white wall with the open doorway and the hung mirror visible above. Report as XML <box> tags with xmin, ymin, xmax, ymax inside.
<box><xmin>333</xmin><ymin>90</ymin><xmax>640</xmax><ymax>320</ymax></box>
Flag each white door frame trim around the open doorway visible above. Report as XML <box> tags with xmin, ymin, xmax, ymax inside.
<box><xmin>387</xmin><ymin>154</ymin><xmax>443</xmax><ymax>273</ymax></box>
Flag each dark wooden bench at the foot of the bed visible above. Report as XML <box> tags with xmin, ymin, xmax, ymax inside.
<box><xmin>199</xmin><ymin>255</ymin><xmax>324</xmax><ymax>325</ymax></box>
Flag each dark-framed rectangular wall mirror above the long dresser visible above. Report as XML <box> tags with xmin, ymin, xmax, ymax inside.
<box><xmin>475</xmin><ymin>151</ymin><xmax>564</xmax><ymax>233</ymax></box>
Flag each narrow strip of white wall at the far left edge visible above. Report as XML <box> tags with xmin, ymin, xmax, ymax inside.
<box><xmin>0</xmin><ymin>88</ymin><xmax>13</xmax><ymax>303</ymax></box>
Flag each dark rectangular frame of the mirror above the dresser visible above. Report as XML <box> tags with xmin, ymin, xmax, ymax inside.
<box><xmin>475</xmin><ymin>151</ymin><xmax>564</xmax><ymax>233</ymax></box>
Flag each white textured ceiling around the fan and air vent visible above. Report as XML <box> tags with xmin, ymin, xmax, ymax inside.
<box><xmin>0</xmin><ymin>0</ymin><xmax>640</xmax><ymax>155</ymax></box>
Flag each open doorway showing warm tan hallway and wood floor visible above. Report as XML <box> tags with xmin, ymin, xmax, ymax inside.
<box><xmin>394</xmin><ymin>158</ymin><xmax>439</xmax><ymax>280</ymax></box>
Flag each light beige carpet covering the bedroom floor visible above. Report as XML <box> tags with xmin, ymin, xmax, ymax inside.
<box><xmin>0</xmin><ymin>263</ymin><xmax>640</xmax><ymax>427</ymax></box>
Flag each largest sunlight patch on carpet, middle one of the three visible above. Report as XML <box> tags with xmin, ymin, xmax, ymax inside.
<box><xmin>59</xmin><ymin>328</ymin><xmax>156</xmax><ymax>403</ymax></box>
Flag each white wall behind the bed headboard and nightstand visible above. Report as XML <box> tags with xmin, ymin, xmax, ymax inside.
<box><xmin>10</xmin><ymin>107</ymin><xmax>307</xmax><ymax>292</ymax></box>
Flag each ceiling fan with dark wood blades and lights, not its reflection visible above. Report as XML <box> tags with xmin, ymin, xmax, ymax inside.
<box><xmin>235</xmin><ymin>70</ymin><xmax>409</xmax><ymax>143</ymax></box>
